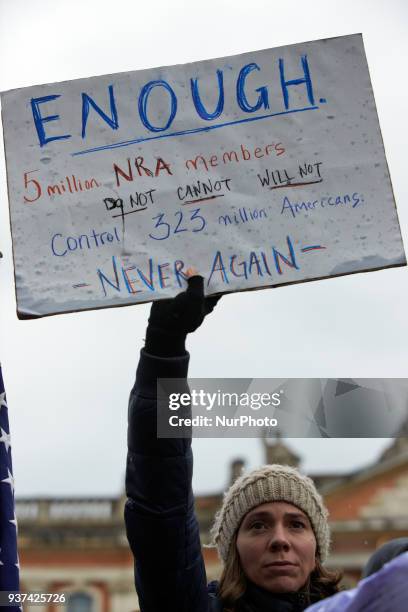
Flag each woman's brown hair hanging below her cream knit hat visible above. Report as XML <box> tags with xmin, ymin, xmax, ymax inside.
<box><xmin>218</xmin><ymin>533</ymin><xmax>342</xmax><ymax>612</ymax></box>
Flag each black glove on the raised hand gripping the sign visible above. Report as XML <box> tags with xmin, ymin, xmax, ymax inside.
<box><xmin>145</xmin><ymin>276</ymin><xmax>221</xmax><ymax>357</ymax></box>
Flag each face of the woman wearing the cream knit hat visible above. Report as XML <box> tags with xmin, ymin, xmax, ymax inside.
<box><xmin>237</xmin><ymin>502</ymin><xmax>316</xmax><ymax>593</ymax></box>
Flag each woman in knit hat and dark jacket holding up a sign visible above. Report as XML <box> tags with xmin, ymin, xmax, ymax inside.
<box><xmin>125</xmin><ymin>269</ymin><xmax>339</xmax><ymax>612</ymax></box>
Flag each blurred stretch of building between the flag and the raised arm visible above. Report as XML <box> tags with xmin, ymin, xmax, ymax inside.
<box><xmin>16</xmin><ymin>497</ymin><xmax>138</xmax><ymax>612</ymax></box>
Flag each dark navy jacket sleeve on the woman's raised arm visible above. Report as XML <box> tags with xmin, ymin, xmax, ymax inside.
<box><xmin>125</xmin><ymin>351</ymin><xmax>208</xmax><ymax>612</ymax></box>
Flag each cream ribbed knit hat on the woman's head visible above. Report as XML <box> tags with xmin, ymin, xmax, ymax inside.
<box><xmin>211</xmin><ymin>464</ymin><xmax>330</xmax><ymax>563</ymax></box>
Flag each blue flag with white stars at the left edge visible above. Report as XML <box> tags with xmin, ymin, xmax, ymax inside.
<box><xmin>0</xmin><ymin>365</ymin><xmax>19</xmax><ymax>596</ymax></box>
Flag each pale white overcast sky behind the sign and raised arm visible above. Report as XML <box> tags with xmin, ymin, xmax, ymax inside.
<box><xmin>0</xmin><ymin>0</ymin><xmax>408</xmax><ymax>497</ymax></box>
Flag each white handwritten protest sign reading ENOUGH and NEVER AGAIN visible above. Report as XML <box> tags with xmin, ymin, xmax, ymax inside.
<box><xmin>2</xmin><ymin>35</ymin><xmax>406</xmax><ymax>318</ymax></box>
